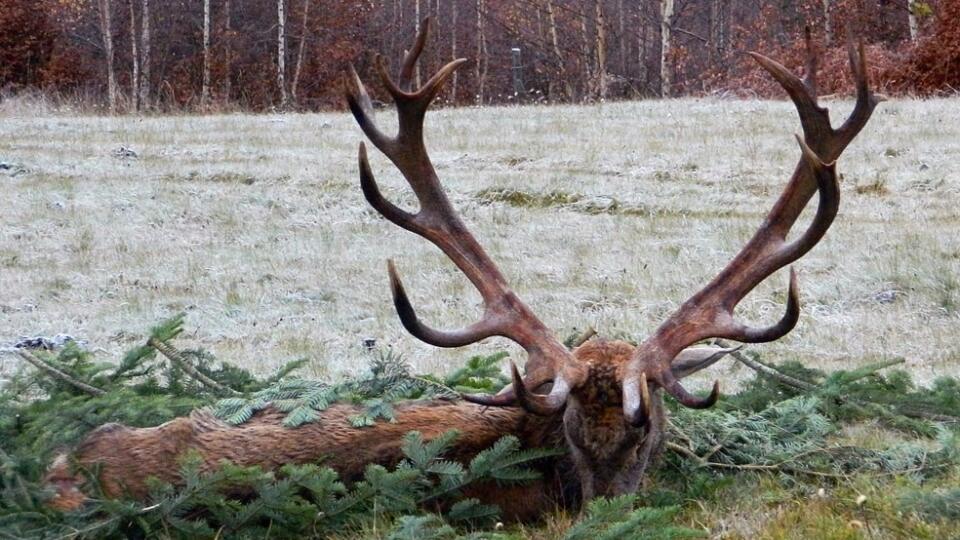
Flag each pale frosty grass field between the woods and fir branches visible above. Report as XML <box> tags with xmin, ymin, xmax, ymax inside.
<box><xmin>0</xmin><ymin>99</ymin><xmax>960</xmax><ymax>392</ymax></box>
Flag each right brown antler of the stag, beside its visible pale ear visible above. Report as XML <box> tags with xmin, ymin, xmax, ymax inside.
<box><xmin>623</xmin><ymin>31</ymin><xmax>883</xmax><ymax>425</ymax></box>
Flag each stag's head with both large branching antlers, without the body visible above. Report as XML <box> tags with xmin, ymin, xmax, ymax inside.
<box><xmin>346</xmin><ymin>20</ymin><xmax>881</xmax><ymax>499</ymax></box>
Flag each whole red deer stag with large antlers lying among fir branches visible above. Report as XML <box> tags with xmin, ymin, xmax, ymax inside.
<box><xmin>49</xmin><ymin>22</ymin><xmax>879</xmax><ymax>519</ymax></box>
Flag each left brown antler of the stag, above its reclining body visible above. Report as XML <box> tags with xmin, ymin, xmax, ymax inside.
<box><xmin>347</xmin><ymin>18</ymin><xmax>585</xmax><ymax>414</ymax></box>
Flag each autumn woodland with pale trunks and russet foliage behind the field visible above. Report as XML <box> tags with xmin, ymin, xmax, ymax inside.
<box><xmin>0</xmin><ymin>0</ymin><xmax>960</xmax><ymax>112</ymax></box>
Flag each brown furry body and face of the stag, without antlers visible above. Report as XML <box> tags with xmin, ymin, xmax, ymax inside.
<box><xmin>47</xmin><ymin>340</ymin><xmax>662</xmax><ymax>521</ymax></box>
